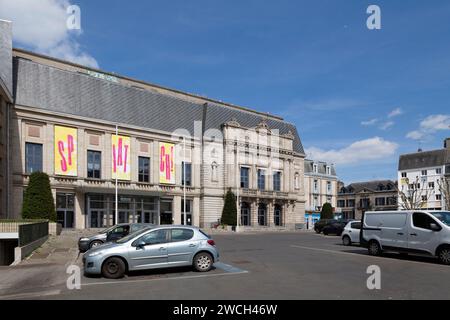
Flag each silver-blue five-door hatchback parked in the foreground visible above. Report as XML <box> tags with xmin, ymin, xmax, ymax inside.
<box><xmin>83</xmin><ymin>226</ymin><xmax>219</xmax><ymax>279</ymax></box>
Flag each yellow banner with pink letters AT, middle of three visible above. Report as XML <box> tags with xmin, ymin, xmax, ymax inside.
<box><xmin>111</xmin><ymin>135</ymin><xmax>131</xmax><ymax>180</ymax></box>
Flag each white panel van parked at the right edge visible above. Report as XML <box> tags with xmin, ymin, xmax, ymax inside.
<box><xmin>361</xmin><ymin>210</ymin><xmax>450</xmax><ymax>265</ymax></box>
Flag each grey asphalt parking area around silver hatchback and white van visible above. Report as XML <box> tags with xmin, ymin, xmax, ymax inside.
<box><xmin>42</xmin><ymin>232</ymin><xmax>450</xmax><ymax>300</ymax></box>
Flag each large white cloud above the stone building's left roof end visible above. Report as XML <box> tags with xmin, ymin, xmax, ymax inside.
<box><xmin>0</xmin><ymin>0</ymin><xmax>98</xmax><ymax>68</ymax></box>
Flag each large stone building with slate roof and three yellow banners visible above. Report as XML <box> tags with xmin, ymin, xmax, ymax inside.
<box><xmin>0</xmin><ymin>26</ymin><xmax>305</xmax><ymax>229</ymax></box>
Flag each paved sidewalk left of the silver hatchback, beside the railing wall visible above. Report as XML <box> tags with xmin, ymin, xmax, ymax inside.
<box><xmin>0</xmin><ymin>230</ymin><xmax>92</xmax><ymax>299</ymax></box>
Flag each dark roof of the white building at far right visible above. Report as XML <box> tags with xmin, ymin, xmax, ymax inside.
<box><xmin>398</xmin><ymin>149</ymin><xmax>450</xmax><ymax>171</ymax></box>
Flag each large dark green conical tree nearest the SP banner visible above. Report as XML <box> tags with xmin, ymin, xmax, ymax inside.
<box><xmin>22</xmin><ymin>172</ymin><xmax>56</xmax><ymax>221</ymax></box>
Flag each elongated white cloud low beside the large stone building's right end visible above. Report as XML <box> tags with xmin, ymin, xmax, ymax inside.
<box><xmin>306</xmin><ymin>137</ymin><xmax>398</xmax><ymax>165</ymax></box>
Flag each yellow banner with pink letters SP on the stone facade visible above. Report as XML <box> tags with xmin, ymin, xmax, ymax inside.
<box><xmin>55</xmin><ymin>126</ymin><xmax>77</xmax><ymax>177</ymax></box>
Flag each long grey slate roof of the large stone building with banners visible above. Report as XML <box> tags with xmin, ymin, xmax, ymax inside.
<box><xmin>14</xmin><ymin>57</ymin><xmax>304</xmax><ymax>154</ymax></box>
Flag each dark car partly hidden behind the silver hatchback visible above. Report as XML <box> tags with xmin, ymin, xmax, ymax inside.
<box><xmin>78</xmin><ymin>223</ymin><xmax>152</xmax><ymax>252</ymax></box>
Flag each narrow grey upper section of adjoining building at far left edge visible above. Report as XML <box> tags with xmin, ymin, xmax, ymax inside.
<box><xmin>0</xmin><ymin>19</ymin><xmax>12</xmax><ymax>101</ymax></box>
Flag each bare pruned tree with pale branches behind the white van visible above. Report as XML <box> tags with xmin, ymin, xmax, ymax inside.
<box><xmin>396</xmin><ymin>177</ymin><xmax>433</xmax><ymax>210</ymax></box>
